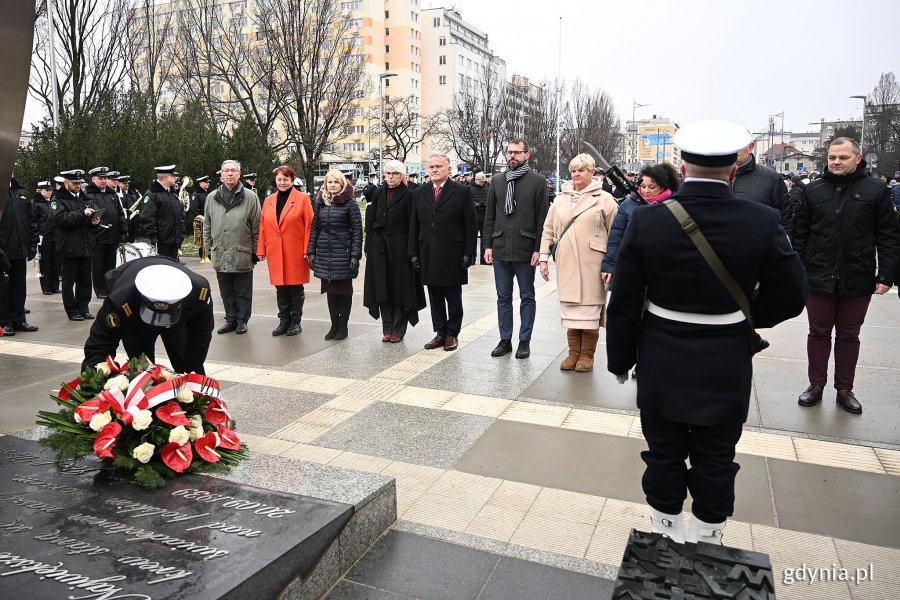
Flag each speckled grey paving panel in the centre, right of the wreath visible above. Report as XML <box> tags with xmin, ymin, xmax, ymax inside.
<box><xmin>312</xmin><ymin>402</ymin><xmax>493</xmax><ymax>469</ymax></box>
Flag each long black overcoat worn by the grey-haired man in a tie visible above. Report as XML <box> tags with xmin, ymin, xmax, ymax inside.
<box><xmin>408</xmin><ymin>179</ymin><xmax>478</xmax><ymax>287</ymax></box>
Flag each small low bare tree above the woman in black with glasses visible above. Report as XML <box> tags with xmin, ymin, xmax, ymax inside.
<box><xmin>369</xmin><ymin>94</ymin><xmax>441</xmax><ymax>161</ymax></box>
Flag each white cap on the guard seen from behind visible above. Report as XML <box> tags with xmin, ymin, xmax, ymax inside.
<box><xmin>672</xmin><ymin>119</ymin><xmax>752</xmax><ymax>167</ymax></box>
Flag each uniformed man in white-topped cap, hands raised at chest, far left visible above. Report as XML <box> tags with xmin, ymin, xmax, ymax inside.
<box><xmin>50</xmin><ymin>169</ymin><xmax>100</xmax><ymax>321</ymax></box>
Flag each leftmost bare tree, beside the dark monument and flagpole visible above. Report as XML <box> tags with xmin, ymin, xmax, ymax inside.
<box><xmin>29</xmin><ymin>0</ymin><xmax>130</xmax><ymax>116</ymax></box>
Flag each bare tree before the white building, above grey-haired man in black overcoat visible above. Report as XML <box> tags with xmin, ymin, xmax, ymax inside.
<box><xmin>438</xmin><ymin>64</ymin><xmax>509</xmax><ymax>172</ymax></box>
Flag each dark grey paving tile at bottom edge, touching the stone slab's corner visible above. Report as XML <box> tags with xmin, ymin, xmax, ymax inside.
<box><xmin>345</xmin><ymin>531</ymin><xmax>500</xmax><ymax>600</ymax></box>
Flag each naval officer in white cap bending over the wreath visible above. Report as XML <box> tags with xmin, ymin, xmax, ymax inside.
<box><xmin>81</xmin><ymin>256</ymin><xmax>215</xmax><ymax>374</ymax></box>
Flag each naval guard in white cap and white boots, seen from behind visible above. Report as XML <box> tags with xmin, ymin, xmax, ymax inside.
<box><xmin>606</xmin><ymin>121</ymin><xmax>806</xmax><ymax>544</ymax></box>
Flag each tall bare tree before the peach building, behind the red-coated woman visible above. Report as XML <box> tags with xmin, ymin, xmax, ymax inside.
<box><xmin>257</xmin><ymin>0</ymin><xmax>370</xmax><ymax>189</ymax></box>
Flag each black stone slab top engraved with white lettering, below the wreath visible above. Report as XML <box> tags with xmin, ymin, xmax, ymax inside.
<box><xmin>0</xmin><ymin>436</ymin><xmax>353</xmax><ymax>600</ymax></box>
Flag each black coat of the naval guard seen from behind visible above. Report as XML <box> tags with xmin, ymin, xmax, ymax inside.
<box><xmin>606</xmin><ymin>181</ymin><xmax>806</xmax><ymax>425</ymax></box>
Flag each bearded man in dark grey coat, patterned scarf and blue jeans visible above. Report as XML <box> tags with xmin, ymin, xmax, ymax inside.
<box><xmin>481</xmin><ymin>139</ymin><xmax>550</xmax><ymax>358</ymax></box>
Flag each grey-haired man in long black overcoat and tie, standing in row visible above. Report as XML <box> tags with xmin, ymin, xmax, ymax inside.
<box><xmin>408</xmin><ymin>154</ymin><xmax>478</xmax><ymax>351</ymax></box>
